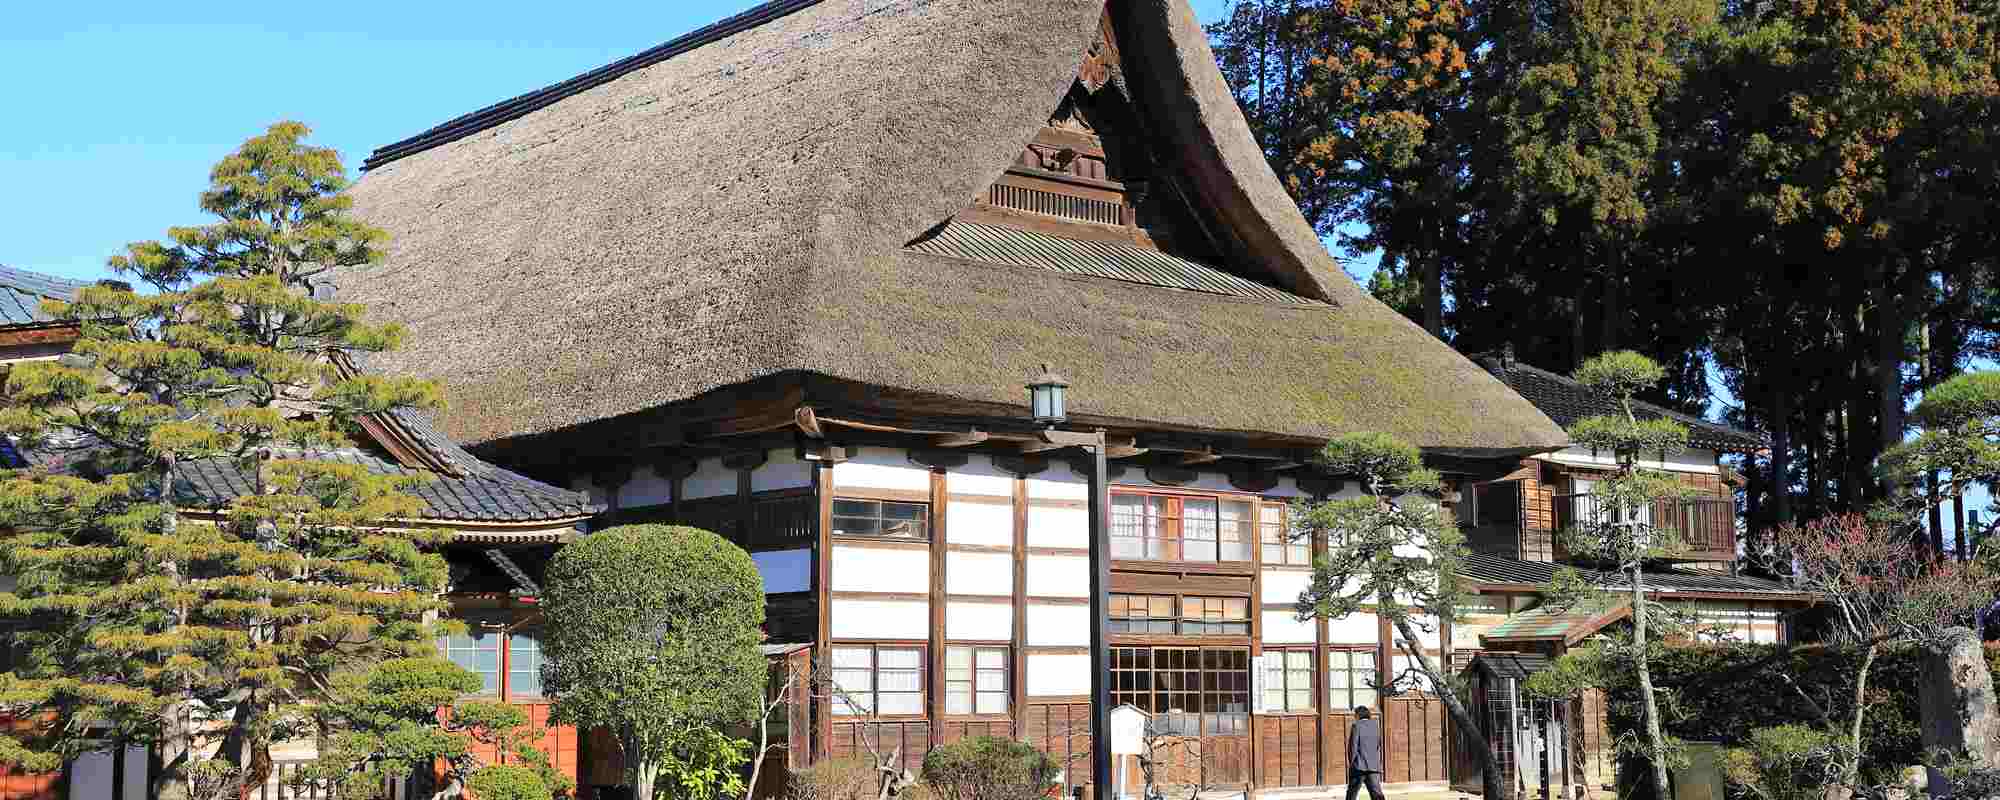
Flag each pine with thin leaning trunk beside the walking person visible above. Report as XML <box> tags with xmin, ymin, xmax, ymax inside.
<box><xmin>1296</xmin><ymin>434</ymin><xmax>1514</xmax><ymax>800</ymax></box>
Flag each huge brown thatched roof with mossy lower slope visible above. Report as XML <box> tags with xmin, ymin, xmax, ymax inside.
<box><xmin>340</xmin><ymin>0</ymin><xmax>1564</xmax><ymax>452</ymax></box>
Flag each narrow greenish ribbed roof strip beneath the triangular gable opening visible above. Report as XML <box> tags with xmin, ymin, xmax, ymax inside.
<box><xmin>910</xmin><ymin>222</ymin><xmax>1320</xmax><ymax>306</ymax></box>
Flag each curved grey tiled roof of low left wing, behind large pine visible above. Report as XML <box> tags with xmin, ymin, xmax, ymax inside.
<box><xmin>0</xmin><ymin>410</ymin><xmax>602</xmax><ymax>524</ymax></box>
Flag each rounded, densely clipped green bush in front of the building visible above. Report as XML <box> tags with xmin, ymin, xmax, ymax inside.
<box><xmin>542</xmin><ymin>524</ymin><xmax>768</xmax><ymax>800</ymax></box>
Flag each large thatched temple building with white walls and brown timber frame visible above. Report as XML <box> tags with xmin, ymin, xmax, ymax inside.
<box><xmin>0</xmin><ymin>0</ymin><xmax>1800</xmax><ymax>798</ymax></box>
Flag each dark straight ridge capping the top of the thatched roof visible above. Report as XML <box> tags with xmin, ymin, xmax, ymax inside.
<box><xmin>362</xmin><ymin>0</ymin><xmax>822</xmax><ymax>172</ymax></box>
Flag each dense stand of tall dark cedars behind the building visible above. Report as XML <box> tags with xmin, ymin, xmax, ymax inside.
<box><xmin>1210</xmin><ymin>0</ymin><xmax>2000</xmax><ymax>536</ymax></box>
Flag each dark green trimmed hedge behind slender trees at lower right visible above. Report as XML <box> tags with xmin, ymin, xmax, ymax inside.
<box><xmin>1606</xmin><ymin>644</ymin><xmax>2000</xmax><ymax>776</ymax></box>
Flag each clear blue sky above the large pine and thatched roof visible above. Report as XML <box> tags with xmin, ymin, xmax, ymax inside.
<box><xmin>0</xmin><ymin>0</ymin><xmax>1226</xmax><ymax>278</ymax></box>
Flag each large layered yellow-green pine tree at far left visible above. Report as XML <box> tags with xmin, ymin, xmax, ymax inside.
<box><xmin>0</xmin><ymin>122</ymin><xmax>448</xmax><ymax>800</ymax></box>
